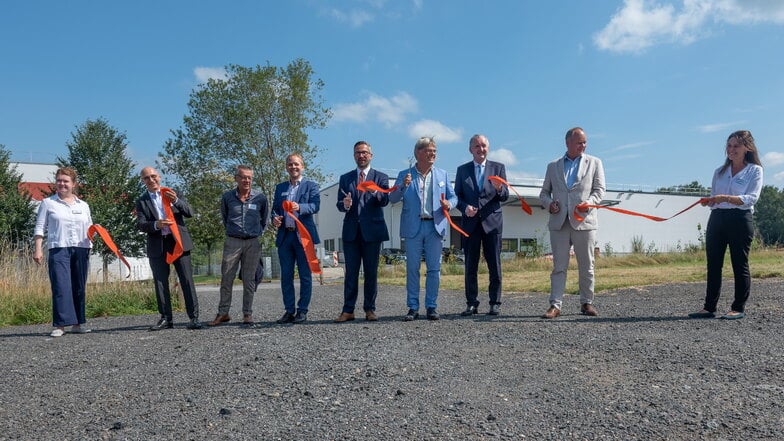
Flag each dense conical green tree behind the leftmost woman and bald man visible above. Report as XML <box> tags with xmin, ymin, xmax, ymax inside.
<box><xmin>57</xmin><ymin>118</ymin><xmax>145</xmax><ymax>282</ymax></box>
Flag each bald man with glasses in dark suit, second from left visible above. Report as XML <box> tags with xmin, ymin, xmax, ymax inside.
<box><xmin>136</xmin><ymin>167</ymin><xmax>202</xmax><ymax>331</ymax></box>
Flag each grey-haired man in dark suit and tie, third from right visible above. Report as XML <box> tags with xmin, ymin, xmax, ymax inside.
<box><xmin>455</xmin><ymin>135</ymin><xmax>509</xmax><ymax>316</ymax></box>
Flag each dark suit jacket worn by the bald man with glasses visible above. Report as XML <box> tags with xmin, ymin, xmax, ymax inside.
<box><xmin>136</xmin><ymin>190</ymin><xmax>193</xmax><ymax>257</ymax></box>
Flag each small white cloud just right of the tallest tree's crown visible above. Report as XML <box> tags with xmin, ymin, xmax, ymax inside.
<box><xmin>332</xmin><ymin>92</ymin><xmax>419</xmax><ymax>126</ymax></box>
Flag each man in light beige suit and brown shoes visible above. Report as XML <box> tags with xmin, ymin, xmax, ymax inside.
<box><xmin>539</xmin><ymin>127</ymin><xmax>605</xmax><ymax>319</ymax></box>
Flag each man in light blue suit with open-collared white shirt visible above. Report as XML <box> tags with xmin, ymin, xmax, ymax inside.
<box><xmin>389</xmin><ymin>136</ymin><xmax>457</xmax><ymax>321</ymax></box>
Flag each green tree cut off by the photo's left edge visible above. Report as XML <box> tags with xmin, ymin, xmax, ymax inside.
<box><xmin>0</xmin><ymin>144</ymin><xmax>35</xmax><ymax>243</ymax></box>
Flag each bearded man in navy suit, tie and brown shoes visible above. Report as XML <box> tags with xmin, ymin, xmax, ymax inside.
<box><xmin>335</xmin><ymin>141</ymin><xmax>389</xmax><ymax>323</ymax></box>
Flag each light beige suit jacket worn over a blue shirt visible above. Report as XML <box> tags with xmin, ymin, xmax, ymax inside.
<box><xmin>539</xmin><ymin>153</ymin><xmax>605</xmax><ymax>230</ymax></box>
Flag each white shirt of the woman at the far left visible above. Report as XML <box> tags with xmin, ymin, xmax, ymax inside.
<box><xmin>34</xmin><ymin>194</ymin><xmax>93</xmax><ymax>249</ymax></box>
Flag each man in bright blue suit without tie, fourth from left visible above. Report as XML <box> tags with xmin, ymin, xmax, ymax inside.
<box><xmin>272</xmin><ymin>153</ymin><xmax>321</xmax><ymax>324</ymax></box>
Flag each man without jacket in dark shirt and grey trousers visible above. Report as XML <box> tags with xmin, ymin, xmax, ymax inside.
<box><xmin>207</xmin><ymin>165</ymin><xmax>269</xmax><ymax>326</ymax></box>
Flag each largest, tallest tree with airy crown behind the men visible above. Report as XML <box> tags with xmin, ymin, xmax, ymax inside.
<box><xmin>159</xmin><ymin>59</ymin><xmax>332</xmax><ymax>251</ymax></box>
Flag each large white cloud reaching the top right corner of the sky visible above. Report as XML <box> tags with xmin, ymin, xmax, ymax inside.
<box><xmin>593</xmin><ymin>0</ymin><xmax>784</xmax><ymax>53</ymax></box>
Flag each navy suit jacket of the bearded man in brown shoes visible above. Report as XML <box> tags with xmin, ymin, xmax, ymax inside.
<box><xmin>337</xmin><ymin>168</ymin><xmax>389</xmax><ymax>242</ymax></box>
